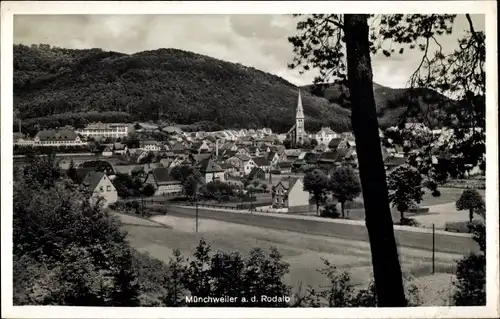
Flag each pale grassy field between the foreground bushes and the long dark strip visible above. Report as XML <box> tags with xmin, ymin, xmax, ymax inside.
<box><xmin>120</xmin><ymin>211</ymin><xmax>461</xmax><ymax>306</ymax></box>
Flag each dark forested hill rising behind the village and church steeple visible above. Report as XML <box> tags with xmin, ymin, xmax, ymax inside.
<box><xmin>14</xmin><ymin>45</ymin><xmax>450</xmax><ymax>132</ymax></box>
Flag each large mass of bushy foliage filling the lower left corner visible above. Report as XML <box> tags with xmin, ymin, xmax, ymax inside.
<box><xmin>13</xmin><ymin>158</ymin><xmax>139</xmax><ymax>306</ymax></box>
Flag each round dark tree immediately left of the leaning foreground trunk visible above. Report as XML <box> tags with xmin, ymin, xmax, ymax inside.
<box><xmin>328</xmin><ymin>166</ymin><xmax>361</xmax><ymax>218</ymax></box>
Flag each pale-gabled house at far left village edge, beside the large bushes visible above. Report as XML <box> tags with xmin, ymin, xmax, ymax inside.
<box><xmin>82</xmin><ymin>171</ymin><xmax>118</xmax><ymax>207</ymax></box>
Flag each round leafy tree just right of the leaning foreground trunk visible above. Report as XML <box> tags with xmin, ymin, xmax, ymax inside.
<box><xmin>387</xmin><ymin>165</ymin><xmax>424</xmax><ymax>223</ymax></box>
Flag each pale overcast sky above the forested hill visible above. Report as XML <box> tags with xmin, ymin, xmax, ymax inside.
<box><xmin>14</xmin><ymin>15</ymin><xmax>485</xmax><ymax>88</ymax></box>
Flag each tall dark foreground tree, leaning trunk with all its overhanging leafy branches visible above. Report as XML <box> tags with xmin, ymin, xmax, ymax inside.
<box><xmin>289</xmin><ymin>14</ymin><xmax>485</xmax><ymax>306</ymax></box>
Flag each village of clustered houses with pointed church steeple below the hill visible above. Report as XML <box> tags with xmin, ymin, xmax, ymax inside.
<box><xmin>10</xmin><ymin>91</ymin><xmax>481</xmax><ymax>229</ymax></box>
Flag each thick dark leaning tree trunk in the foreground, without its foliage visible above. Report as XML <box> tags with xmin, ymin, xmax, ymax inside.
<box><xmin>344</xmin><ymin>14</ymin><xmax>407</xmax><ymax>307</ymax></box>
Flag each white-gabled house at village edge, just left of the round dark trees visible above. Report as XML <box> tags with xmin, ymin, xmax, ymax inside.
<box><xmin>271</xmin><ymin>178</ymin><xmax>311</xmax><ymax>212</ymax></box>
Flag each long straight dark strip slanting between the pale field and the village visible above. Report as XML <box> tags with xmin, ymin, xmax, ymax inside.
<box><xmin>163</xmin><ymin>206</ymin><xmax>479</xmax><ymax>254</ymax></box>
